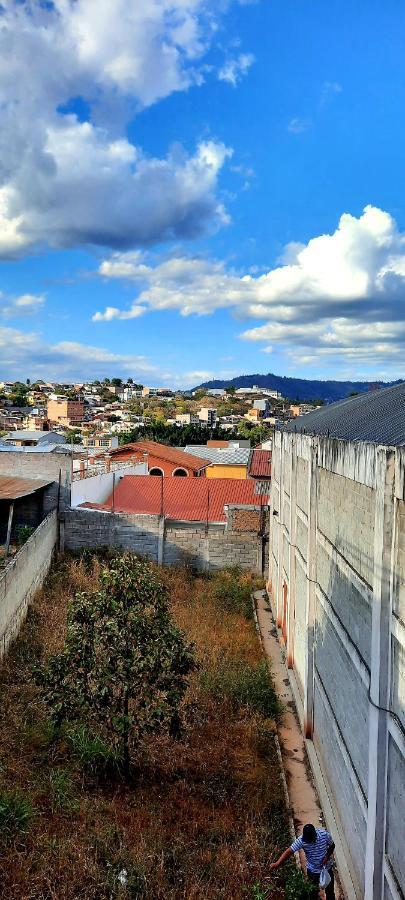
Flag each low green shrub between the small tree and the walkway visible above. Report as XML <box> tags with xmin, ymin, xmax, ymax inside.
<box><xmin>201</xmin><ymin>657</ymin><xmax>281</xmax><ymax>719</ymax></box>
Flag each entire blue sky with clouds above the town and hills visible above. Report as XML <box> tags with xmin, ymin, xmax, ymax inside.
<box><xmin>0</xmin><ymin>0</ymin><xmax>405</xmax><ymax>386</ymax></box>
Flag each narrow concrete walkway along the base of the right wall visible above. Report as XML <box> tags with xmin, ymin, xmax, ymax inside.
<box><xmin>254</xmin><ymin>591</ymin><xmax>343</xmax><ymax>900</ymax></box>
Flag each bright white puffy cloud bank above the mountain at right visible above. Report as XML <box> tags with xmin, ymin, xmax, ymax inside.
<box><xmin>96</xmin><ymin>206</ymin><xmax>405</xmax><ymax>368</ymax></box>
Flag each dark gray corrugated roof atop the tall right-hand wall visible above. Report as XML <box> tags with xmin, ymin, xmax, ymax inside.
<box><xmin>285</xmin><ymin>382</ymin><xmax>405</xmax><ymax>447</ymax></box>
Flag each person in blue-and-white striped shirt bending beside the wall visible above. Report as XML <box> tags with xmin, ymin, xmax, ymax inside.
<box><xmin>270</xmin><ymin>825</ymin><xmax>335</xmax><ymax>900</ymax></box>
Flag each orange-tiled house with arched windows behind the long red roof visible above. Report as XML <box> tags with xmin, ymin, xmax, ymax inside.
<box><xmin>110</xmin><ymin>441</ymin><xmax>209</xmax><ymax>477</ymax></box>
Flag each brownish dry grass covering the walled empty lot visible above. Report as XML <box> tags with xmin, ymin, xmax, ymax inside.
<box><xmin>0</xmin><ymin>557</ymin><xmax>288</xmax><ymax>900</ymax></box>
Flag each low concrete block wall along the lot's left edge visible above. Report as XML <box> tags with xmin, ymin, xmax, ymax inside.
<box><xmin>0</xmin><ymin>510</ymin><xmax>58</xmax><ymax>658</ymax></box>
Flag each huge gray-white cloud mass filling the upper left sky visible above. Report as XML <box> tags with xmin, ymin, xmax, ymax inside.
<box><xmin>0</xmin><ymin>0</ymin><xmax>246</xmax><ymax>258</ymax></box>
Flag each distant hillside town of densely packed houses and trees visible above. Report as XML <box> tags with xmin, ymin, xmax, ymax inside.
<box><xmin>0</xmin><ymin>378</ymin><xmax>316</xmax><ymax>453</ymax></box>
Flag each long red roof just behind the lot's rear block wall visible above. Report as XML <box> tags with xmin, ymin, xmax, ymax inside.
<box><xmin>82</xmin><ymin>475</ymin><xmax>268</xmax><ymax>522</ymax></box>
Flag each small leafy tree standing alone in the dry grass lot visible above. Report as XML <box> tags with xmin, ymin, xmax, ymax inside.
<box><xmin>41</xmin><ymin>553</ymin><xmax>194</xmax><ymax>776</ymax></box>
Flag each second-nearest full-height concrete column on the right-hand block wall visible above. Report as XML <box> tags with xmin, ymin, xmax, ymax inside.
<box><xmin>304</xmin><ymin>438</ymin><xmax>318</xmax><ymax>738</ymax></box>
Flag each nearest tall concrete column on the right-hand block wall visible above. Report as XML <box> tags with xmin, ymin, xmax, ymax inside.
<box><xmin>364</xmin><ymin>447</ymin><xmax>396</xmax><ymax>900</ymax></box>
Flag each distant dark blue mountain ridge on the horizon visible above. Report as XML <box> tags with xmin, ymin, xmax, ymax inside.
<box><xmin>194</xmin><ymin>372</ymin><xmax>402</xmax><ymax>403</ymax></box>
